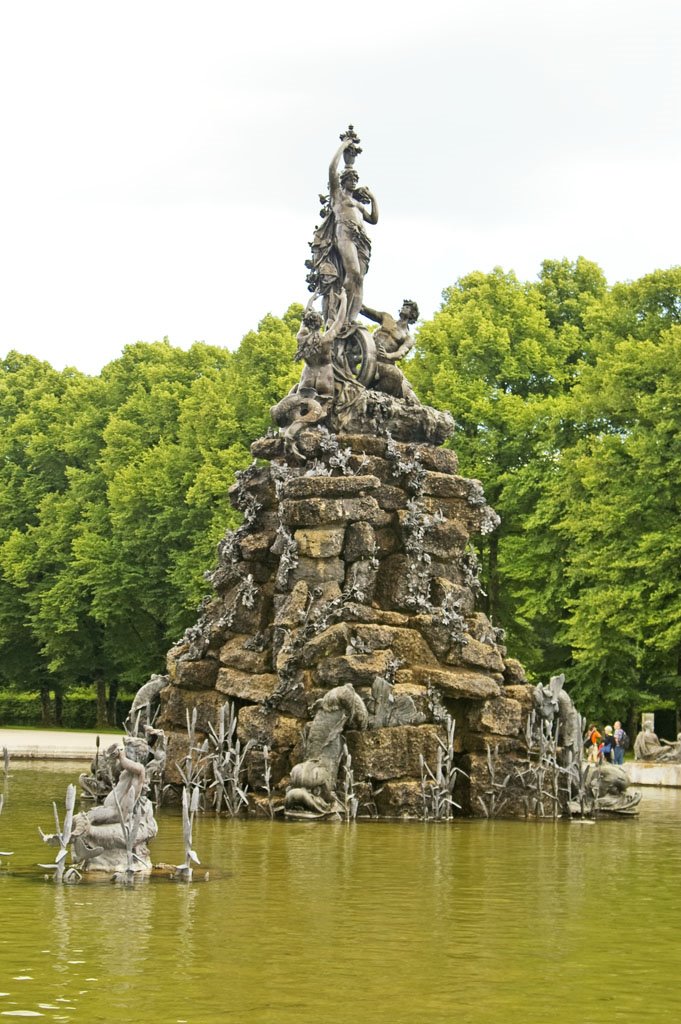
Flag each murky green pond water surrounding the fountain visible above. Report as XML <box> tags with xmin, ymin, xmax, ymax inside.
<box><xmin>0</xmin><ymin>763</ymin><xmax>681</xmax><ymax>1024</ymax></box>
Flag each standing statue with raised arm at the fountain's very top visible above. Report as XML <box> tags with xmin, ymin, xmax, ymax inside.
<box><xmin>306</xmin><ymin>125</ymin><xmax>378</xmax><ymax>324</ymax></box>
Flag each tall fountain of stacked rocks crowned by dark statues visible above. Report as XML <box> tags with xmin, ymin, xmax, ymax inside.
<box><xmin>142</xmin><ymin>127</ymin><xmax>639</xmax><ymax>817</ymax></box>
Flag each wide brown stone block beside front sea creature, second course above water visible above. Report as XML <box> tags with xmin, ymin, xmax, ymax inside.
<box><xmin>346</xmin><ymin>725</ymin><xmax>441</xmax><ymax>779</ymax></box>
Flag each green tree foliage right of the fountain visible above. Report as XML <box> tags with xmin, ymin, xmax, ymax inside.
<box><xmin>410</xmin><ymin>258</ymin><xmax>681</xmax><ymax>717</ymax></box>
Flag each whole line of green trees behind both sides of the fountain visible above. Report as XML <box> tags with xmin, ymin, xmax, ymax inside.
<box><xmin>0</xmin><ymin>258</ymin><xmax>681</xmax><ymax>721</ymax></box>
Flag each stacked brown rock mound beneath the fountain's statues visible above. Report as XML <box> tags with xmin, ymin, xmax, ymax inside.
<box><xmin>160</xmin><ymin>429</ymin><xmax>531</xmax><ymax>816</ymax></box>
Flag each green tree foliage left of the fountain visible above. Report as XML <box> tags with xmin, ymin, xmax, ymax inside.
<box><xmin>0</xmin><ymin>306</ymin><xmax>301</xmax><ymax>707</ymax></box>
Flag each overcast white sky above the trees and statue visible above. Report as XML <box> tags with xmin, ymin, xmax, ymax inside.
<box><xmin>0</xmin><ymin>0</ymin><xmax>681</xmax><ymax>373</ymax></box>
